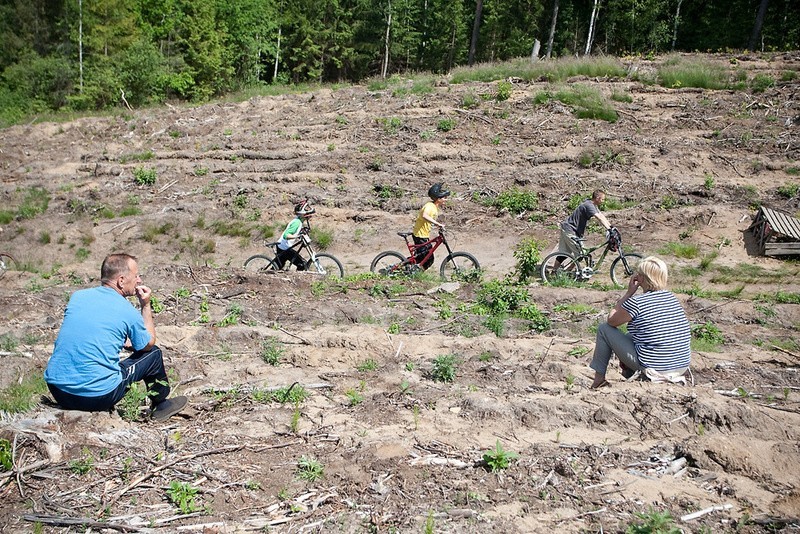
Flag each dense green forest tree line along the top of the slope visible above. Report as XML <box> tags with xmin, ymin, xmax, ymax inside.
<box><xmin>0</xmin><ymin>0</ymin><xmax>800</xmax><ymax>120</ymax></box>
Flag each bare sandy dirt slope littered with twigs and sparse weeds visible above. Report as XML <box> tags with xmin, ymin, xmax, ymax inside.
<box><xmin>0</xmin><ymin>53</ymin><xmax>800</xmax><ymax>533</ymax></box>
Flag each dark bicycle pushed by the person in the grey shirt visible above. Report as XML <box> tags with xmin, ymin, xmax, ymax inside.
<box><xmin>539</xmin><ymin>227</ymin><xmax>643</xmax><ymax>287</ymax></box>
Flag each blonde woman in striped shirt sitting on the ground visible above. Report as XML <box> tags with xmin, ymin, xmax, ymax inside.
<box><xmin>589</xmin><ymin>256</ymin><xmax>691</xmax><ymax>389</ymax></box>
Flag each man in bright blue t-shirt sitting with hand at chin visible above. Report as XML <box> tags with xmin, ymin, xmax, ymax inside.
<box><xmin>44</xmin><ymin>254</ymin><xmax>187</xmax><ymax>421</ymax></box>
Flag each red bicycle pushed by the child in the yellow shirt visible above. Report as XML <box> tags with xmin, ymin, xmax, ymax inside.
<box><xmin>369</xmin><ymin>229</ymin><xmax>481</xmax><ymax>280</ymax></box>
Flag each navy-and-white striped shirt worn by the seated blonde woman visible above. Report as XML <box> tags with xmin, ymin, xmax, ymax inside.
<box><xmin>622</xmin><ymin>290</ymin><xmax>692</xmax><ymax>372</ymax></box>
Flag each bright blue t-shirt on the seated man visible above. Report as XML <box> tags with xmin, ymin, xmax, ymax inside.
<box><xmin>44</xmin><ymin>286</ymin><xmax>152</xmax><ymax>397</ymax></box>
